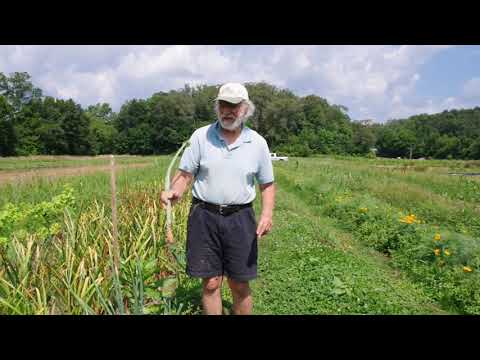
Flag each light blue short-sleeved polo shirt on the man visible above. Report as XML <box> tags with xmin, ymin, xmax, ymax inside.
<box><xmin>179</xmin><ymin>121</ymin><xmax>274</xmax><ymax>205</ymax></box>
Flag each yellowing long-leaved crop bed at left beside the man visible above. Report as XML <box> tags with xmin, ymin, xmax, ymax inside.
<box><xmin>0</xmin><ymin>153</ymin><xmax>190</xmax><ymax>314</ymax></box>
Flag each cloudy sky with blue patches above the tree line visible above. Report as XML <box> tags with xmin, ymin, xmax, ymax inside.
<box><xmin>0</xmin><ymin>45</ymin><xmax>480</xmax><ymax>122</ymax></box>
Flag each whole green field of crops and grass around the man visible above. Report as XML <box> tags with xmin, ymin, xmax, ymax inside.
<box><xmin>0</xmin><ymin>156</ymin><xmax>480</xmax><ymax>314</ymax></box>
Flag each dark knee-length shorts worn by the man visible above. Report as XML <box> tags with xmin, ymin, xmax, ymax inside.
<box><xmin>186</xmin><ymin>204</ymin><xmax>257</xmax><ymax>281</ymax></box>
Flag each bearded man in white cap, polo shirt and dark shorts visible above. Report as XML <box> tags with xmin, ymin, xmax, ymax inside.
<box><xmin>161</xmin><ymin>83</ymin><xmax>275</xmax><ymax>315</ymax></box>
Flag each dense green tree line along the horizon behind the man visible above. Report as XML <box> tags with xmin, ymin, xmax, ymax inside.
<box><xmin>0</xmin><ymin>72</ymin><xmax>480</xmax><ymax>159</ymax></box>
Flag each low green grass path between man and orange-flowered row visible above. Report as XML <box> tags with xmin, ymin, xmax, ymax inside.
<box><xmin>249</xmin><ymin>168</ymin><xmax>445</xmax><ymax>314</ymax></box>
